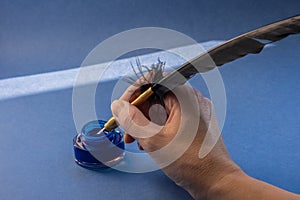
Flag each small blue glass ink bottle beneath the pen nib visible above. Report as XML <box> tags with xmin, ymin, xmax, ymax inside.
<box><xmin>73</xmin><ymin>120</ymin><xmax>125</xmax><ymax>169</ymax></box>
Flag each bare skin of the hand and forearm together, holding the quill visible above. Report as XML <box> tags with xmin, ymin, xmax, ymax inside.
<box><xmin>111</xmin><ymin>75</ymin><xmax>300</xmax><ymax>200</ymax></box>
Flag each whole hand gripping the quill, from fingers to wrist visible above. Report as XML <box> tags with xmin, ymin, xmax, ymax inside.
<box><xmin>111</xmin><ymin>77</ymin><xmax>241</xmax><ymax>199</ymax></box>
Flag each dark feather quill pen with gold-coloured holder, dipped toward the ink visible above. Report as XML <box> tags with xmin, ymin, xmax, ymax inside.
<box><xmin>99</xmin><ymin>15</ymin><xmax>300</xmax><ymax>134</ymax></box>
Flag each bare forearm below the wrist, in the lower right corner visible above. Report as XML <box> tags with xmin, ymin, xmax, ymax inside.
<box><xmin>207</xmin><ymin>172</ymin><xmax>300</xmax><ymax>200</ymax></box>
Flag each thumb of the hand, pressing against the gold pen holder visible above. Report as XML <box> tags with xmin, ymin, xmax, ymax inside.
<box><xmin>111</xmin><ymin>100</ymin><xmax>163</xmax><ymax>138</ymax></box>
